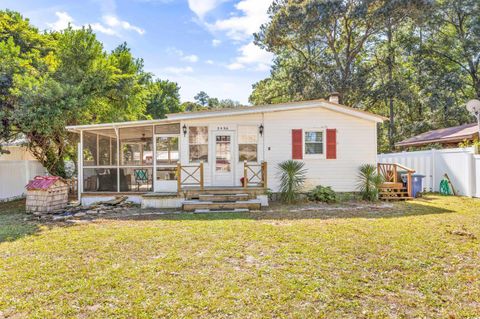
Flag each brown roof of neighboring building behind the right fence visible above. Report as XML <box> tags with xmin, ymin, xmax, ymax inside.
<box><xmin>395</xmin><ymin>123</ymin><xmax>478</xmax><ymax>147</ymax></box>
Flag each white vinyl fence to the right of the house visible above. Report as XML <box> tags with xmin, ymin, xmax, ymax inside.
<box><xmin>378</xmin><ymin>148</ymin><xmax>480</xmax><ymax>197</ymax></box>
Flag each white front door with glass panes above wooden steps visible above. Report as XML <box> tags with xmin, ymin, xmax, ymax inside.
<box><xmin>212</xmin><ymin>131</ymin><xmax>235</xmax><ymax>186</ymax></box>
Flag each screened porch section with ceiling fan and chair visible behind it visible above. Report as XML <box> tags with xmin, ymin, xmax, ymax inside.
<box><xmin>119</xmin><ymin>126</ymin><xmax>153</xmax><ymax>192</ymax></box>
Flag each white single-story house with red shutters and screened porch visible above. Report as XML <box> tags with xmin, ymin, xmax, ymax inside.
<box><xmin>67</xmin><ymin>95</ymin><xmax>385</xmax><ymax>207</ymax></box>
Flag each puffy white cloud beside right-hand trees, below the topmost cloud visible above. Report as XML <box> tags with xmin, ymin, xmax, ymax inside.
<box><xmin>227</xmin><ymin>42</ymin><xmax>273</xmax><ymax>71</ymax></box>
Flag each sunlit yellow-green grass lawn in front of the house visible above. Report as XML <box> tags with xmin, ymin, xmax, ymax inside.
<box><xmin>0</xmin><ymin>195</ymin><xmax>480</xmax><ymax>318</ymax></box>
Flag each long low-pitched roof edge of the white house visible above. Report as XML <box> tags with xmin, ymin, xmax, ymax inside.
<box><xmin>67</xmin><ymin>100</ymin><xmax>387</xmax><ymax>132</ymax></box>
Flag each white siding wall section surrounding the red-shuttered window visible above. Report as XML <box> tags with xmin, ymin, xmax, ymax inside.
<box><xmin>264</xmin><ymin>109</ymin><xmax>377</xmax><ymax>192</ymax></box>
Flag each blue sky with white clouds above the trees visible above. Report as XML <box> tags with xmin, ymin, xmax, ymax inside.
<box><xmin>0</xmin><ymin>0</ymin><xmax>272</xmax><ymax>104</ymax></box>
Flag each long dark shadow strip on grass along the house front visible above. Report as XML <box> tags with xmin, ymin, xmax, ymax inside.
<box><xmin>0</xmin><ymin>198</ymin><xmax>454</xmax><ymax>243</ymax></box>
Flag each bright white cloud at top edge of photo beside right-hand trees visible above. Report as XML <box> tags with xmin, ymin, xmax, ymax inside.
<box><xmin>208</xmin><ymin>0</ymin><xmax>272</xmax><ymax>41</ymax></box>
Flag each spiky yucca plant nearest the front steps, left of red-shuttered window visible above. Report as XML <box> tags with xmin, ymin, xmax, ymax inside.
<box><xmin>278</xmin><ymin>160</ymin><xmax>307</xmax><ymax>203</ymax></box>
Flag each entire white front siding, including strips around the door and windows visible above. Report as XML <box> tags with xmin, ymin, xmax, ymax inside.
<box><xmin>180</xmin><ymin>108</ymin><xmax>377</xmax><ymax>192</ymax></box>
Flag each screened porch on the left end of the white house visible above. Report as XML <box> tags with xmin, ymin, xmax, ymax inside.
<box><xmin>79</xmin><ymin>123</ymin><xmax>180</xmax><ymax>193</ymax></box>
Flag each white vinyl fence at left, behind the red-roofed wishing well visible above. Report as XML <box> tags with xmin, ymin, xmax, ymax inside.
<box><xmin>0</xmin><ymin>161</ymin><xmax>46</xmax><ymax>201</ymax></box>
